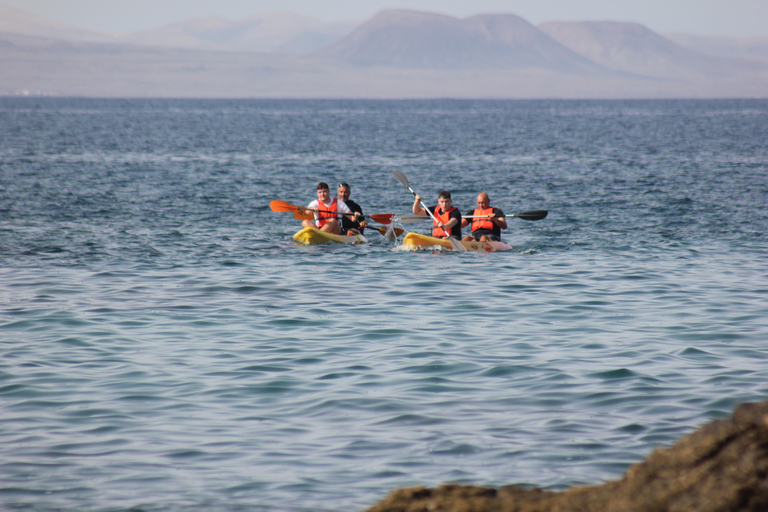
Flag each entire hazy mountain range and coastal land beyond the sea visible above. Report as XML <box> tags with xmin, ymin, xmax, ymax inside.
<box><xmin>0</xmin><ymin>6</ymin><xmax>768</xmax><ymax>98</ymax></box>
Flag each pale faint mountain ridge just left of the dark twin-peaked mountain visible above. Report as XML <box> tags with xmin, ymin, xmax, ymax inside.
<box><xmin>122</xmin><ymin>12</ymin><xmax>359</xmax><ymax>54</ymax></box>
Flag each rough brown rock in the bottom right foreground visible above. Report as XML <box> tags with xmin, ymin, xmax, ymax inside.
<box><xmin>367</xmin><ymin>402</ymin><xmax>768</xmax><ymax>512</ymax></box>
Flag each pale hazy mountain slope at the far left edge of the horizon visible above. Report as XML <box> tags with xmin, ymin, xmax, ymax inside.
<box><xmin>0</xmin><ymin>5</ymin><xmax>114</xmax><ymax>43</ymax></box>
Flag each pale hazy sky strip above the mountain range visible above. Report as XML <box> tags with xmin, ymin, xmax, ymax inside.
<box><xmin>0</xmin><ymin>0</ymin><xmax>768</xmax><ymax>36</ymax></box>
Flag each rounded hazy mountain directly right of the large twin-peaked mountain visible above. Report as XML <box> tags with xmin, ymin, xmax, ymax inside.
<box><xmin>538</xmin><ymin>21</ymin><xmax>764</xmax><ymax>78</ymax></box>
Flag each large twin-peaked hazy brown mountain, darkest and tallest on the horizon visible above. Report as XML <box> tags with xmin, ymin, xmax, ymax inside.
<box><xmin>317</xmin><ymin>10</ymin><xmax>606</xmax><ymax>73</ymax></box>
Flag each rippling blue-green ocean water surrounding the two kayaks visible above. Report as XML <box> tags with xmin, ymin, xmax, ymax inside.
<box><xmin>0</xmin><ymin>98</ymin><xmax>768</xmax><ymax>512</ymax></box>
